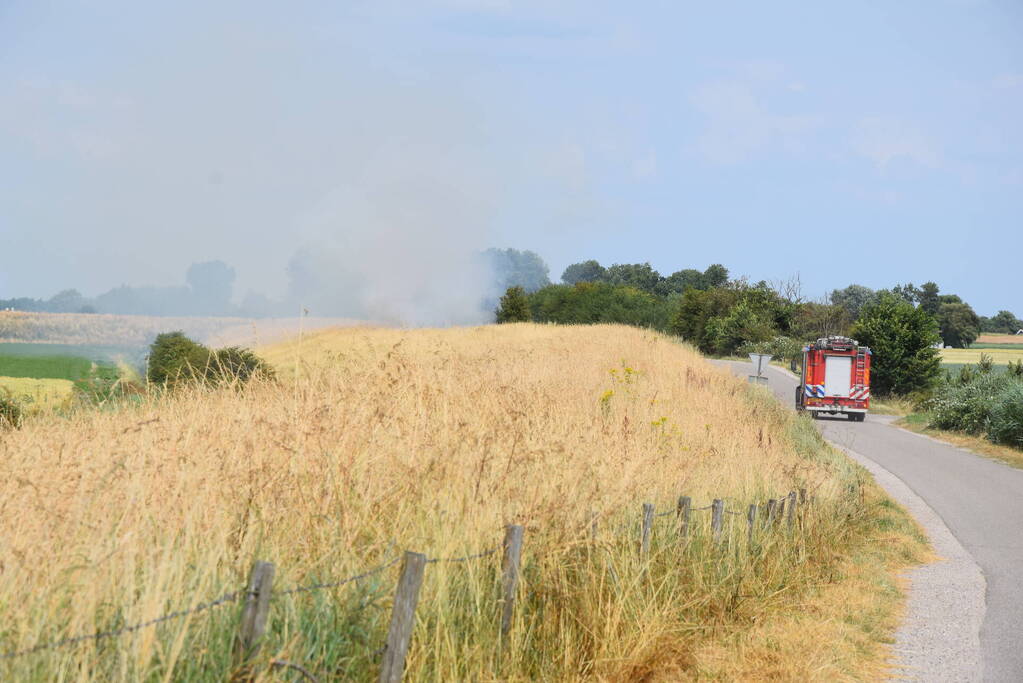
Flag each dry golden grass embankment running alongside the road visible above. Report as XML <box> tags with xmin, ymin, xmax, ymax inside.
<box><xmin>0</xmin><ymin>325</ymin><xmax>925</xmax><ymax>680</ymax></box>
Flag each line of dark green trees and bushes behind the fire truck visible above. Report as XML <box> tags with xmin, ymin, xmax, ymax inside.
<box><xmin>496</xmin><ymin>260</ymin><xmax>1023</xmax><ymax>395</ymax></box>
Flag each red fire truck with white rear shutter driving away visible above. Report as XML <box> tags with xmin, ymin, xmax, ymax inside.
<box><xmin>796</xmin><ymin>336</ymin><xmax>871</xmax><ymax>422</ymax></box>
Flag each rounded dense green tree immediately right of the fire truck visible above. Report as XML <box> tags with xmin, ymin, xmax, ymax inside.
<box><xmin>852</xmin><ymin>292</ymin><xmax>941</xmax><ymax>395</ymax></box>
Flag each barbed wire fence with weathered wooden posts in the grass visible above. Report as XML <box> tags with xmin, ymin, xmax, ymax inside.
<box><xmin>0</xmin><ymin>489</ymin><xmax>812</xmax><ymax>682</ymax></box>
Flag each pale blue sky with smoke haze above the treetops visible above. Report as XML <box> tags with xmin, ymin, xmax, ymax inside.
<box><xmin>0</xmin><ymin>0</ymin><xmax>1023</xmax><ymax>315</ymax></box>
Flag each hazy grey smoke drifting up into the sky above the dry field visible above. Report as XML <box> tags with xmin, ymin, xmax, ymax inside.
<box><xmin>0</xmin><ymin>3</ymin><xmax>500</xmax><ymax>325</ymax></box>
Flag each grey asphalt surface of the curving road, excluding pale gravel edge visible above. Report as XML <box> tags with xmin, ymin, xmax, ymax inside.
<box><xmin>728</xmin><ymin>363</ymin><xmax>1023</xmax><ymax>681</ymax></box>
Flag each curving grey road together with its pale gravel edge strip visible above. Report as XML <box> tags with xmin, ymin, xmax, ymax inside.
<box><xmin>722</xmin><ymin>362</ymin><xmax>1023</xmax><ymax>682</ymax></box>
